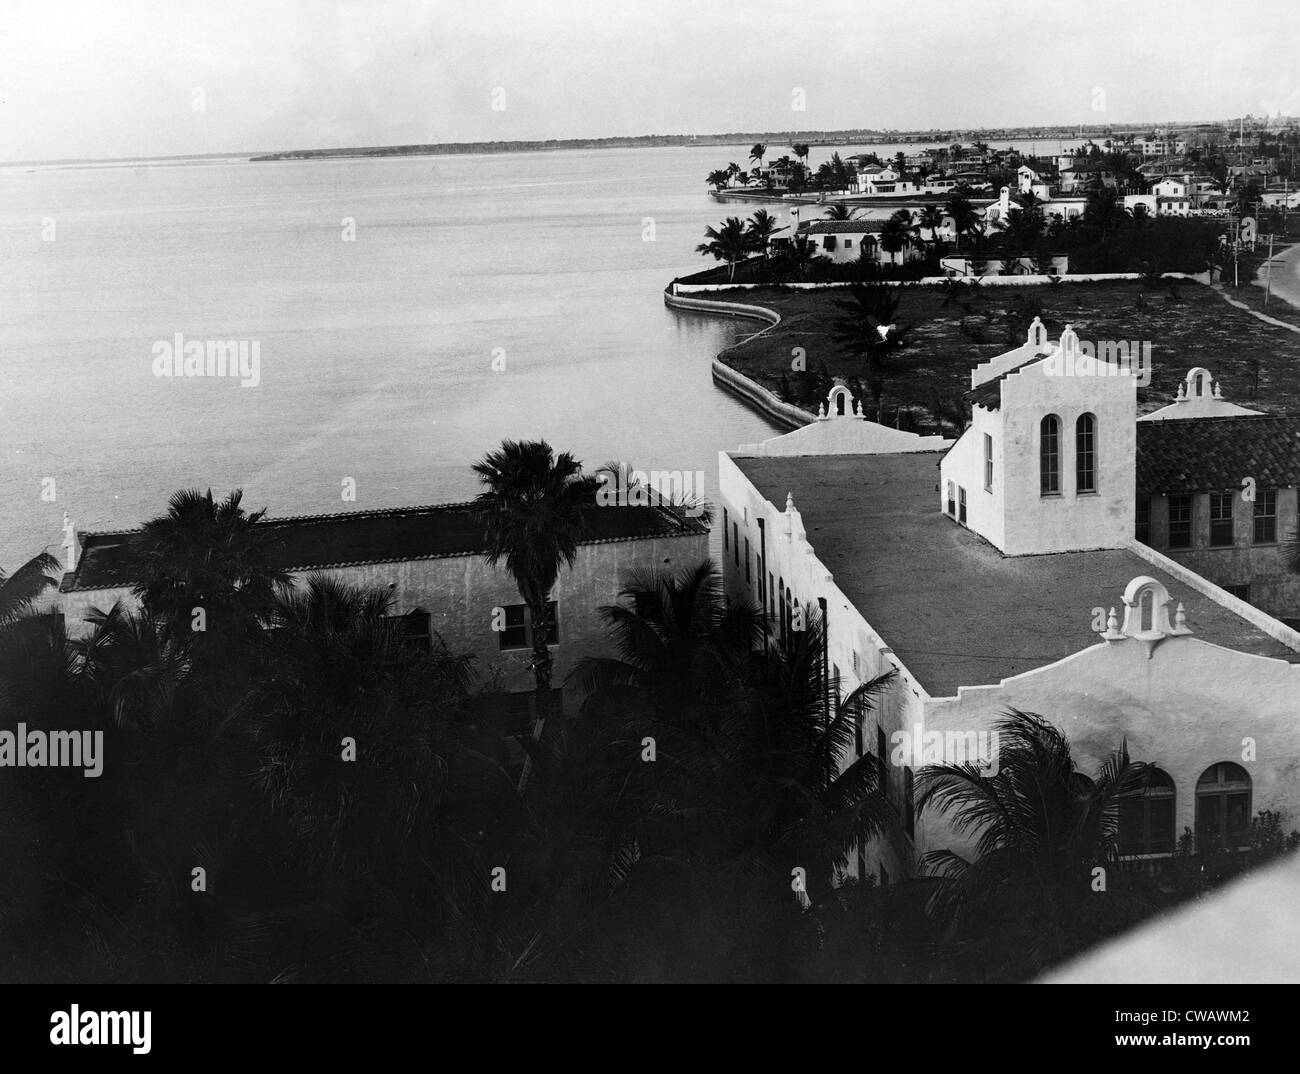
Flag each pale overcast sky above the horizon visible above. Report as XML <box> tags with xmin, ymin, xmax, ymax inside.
<box><xmin>0</xmin><ymin>0</ymin><xmax>1300</xmax><ymax>160</ymax></box>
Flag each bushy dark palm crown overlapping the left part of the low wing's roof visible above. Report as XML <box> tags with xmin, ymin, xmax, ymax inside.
<box><xmin>134</xmin><ymin>489</ymin><xmax>289</xmax><ymax>642</ymax></box>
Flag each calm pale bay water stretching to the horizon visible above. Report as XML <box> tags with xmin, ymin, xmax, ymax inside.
<box><xmin>0</xmin><ymin>137</ymin><xmax>1066</xmax><ymax>570</ymax></box>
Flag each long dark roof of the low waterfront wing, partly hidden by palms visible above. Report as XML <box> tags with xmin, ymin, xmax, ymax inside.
<box><xmin>60</xmin><ymin>502</ymin><xmax>709</xmax><ymax>593</ymax></box>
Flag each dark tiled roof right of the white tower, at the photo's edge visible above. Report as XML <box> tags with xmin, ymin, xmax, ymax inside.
<box><xmin>1138</xmin><ymin>415</ymin><xmax>1300</xmax><ymax>495</ymax></box>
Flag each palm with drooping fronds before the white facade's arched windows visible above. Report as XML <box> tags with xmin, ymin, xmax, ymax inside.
<box><xmin>917</xmin><ymin>710</ymin><xmax>1151</xmax><ymax>975</ymax></box>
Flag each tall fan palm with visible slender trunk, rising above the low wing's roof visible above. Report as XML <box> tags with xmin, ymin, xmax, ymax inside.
<box><xmin>473</xmin><ymin>434</ymin><xmax>592</xmax><ymax>732</ymax></box>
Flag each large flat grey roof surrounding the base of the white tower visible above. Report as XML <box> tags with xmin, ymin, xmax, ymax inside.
<box><xmin>732</xmin><ymin>451</ymin><xmax>1300</xmax><ymax>697</ymax></box>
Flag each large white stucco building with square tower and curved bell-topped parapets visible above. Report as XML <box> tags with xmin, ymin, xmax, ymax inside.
<box><xmin>720</xmin><ymin>324</ymin><xmax>1300</xmax><ymax>880</ymax></box>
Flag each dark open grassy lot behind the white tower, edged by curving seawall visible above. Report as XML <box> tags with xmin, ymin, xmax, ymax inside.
<box><xmin>711</xmin><ymin>280</ymin><xmax>1300</xmax><ymax>432</ymax></box>
